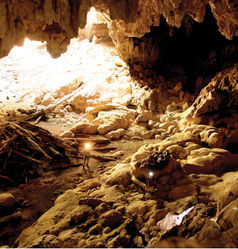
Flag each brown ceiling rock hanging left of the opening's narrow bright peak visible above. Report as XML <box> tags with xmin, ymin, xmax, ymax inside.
<box><xmin>0</xmin><ymin>0</ymin><xmax>90</xmax><ymax>57</ymax></box>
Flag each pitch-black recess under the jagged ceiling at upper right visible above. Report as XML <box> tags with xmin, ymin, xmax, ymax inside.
<box><xmin>129</xmin><ymin>6</ymin><xmax>238</xmax><ymax>92</ymax></box>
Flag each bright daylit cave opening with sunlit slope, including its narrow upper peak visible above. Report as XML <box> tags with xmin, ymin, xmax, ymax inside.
<box><xmin>0</xmin><ymin>8</ymin><xmax>131</xmax><ymax>133</ymax></box>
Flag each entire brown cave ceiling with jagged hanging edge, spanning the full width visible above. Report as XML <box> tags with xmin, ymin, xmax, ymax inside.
<box><xmin>0</xmin><ymin>0</ymin><xmax>238</xmax><ymax>61</ymax></box>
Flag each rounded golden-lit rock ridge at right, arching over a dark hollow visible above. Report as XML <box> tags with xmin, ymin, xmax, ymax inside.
<box><xmin>131</xmin><ymin>125</ymin><xmax>237</xmax><ymax>177</ymax></box>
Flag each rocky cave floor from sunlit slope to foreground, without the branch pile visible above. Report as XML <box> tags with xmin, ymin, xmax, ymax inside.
<box><xmin>0</xmin><ymin>38</ymin><xmax>238</xmax><ymax>248</ymax></box>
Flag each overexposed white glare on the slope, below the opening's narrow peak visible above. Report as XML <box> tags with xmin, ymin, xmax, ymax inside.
<box><xmin>0</xmin><ymin>32</ymin><xmax>131</xmax><ymax>113</ymax></box>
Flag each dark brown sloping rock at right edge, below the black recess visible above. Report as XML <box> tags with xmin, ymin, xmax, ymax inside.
<box><xmin>186</xmin><ymin>64</ymin><xmax>238</xmax><ymax>129</ymax></box>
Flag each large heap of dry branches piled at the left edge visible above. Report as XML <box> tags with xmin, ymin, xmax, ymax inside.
<box><xmin>0</xmin><ymin>120</ymin><xmax>78</xmax><ymax>186</ymax></box>
